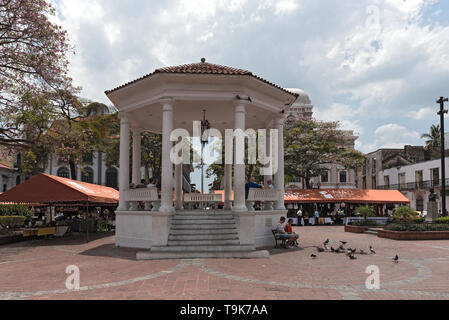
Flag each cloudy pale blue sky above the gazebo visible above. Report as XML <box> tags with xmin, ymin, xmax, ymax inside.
<box><xmin>50</xmin><ymin>0</ymin><xmax>449</xmax><ymax>156</ymax></box>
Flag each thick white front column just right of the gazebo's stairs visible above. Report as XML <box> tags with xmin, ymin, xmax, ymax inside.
<box><xmin>232</xmin><ymin>101</ymin><xmax>248</xmax><ymax>212</ymax></box>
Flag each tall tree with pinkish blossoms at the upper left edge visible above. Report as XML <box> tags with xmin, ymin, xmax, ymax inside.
<box><xmin>0</xmin><ymin>0</ymin><xmax>75</xmax><ymax>148</ymax></box>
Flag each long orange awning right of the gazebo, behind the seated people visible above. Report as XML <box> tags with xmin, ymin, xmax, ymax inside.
<box><xmin>285</xmin><ymin>189</ymin><xmax>410</xmax><ymax>204</ymax></box>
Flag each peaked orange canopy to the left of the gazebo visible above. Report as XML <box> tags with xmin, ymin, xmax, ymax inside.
<box><xmin>0</xmin><ymin>173</ymin><xmax>119</xmax><ymax>205</ymax></box>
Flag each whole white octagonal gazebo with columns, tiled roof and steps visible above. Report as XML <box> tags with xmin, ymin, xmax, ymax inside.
<box><xmin>106</xmin><ymin>59</ymin><xmax>297</xmax><ymax>259</ymax></box>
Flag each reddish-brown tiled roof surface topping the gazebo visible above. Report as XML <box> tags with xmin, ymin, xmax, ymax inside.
<box><xmin>105</xmin><ymin>62</ymin><xmax>299</xmax><ymax>97</ymax></box>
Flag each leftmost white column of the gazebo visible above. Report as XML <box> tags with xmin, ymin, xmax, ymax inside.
<box><xmin>117</xmin><ymin>114</ymin><xmax>130</xmax><ymax>211</ymax></box>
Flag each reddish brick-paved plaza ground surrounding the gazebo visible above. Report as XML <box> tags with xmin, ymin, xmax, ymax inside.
<box><xmin>0</xmin><ymin>227</ymin><xmax>449</xmax><ymax>300</ymax></box>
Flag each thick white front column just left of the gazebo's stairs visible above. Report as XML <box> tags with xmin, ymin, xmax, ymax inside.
<box><xmin>159</xmin><ymin>99</ymin><xmax>174</xmax><ymax>212</ymax></box>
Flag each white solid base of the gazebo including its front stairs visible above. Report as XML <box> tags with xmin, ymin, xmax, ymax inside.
<box><xmin>115</xmin><ymin>210</ymin><xmax>287</xmax><ymax>254</ymax></box>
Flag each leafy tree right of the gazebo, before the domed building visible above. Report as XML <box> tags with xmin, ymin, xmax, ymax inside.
<box><xmin>284</xmin><ymin>120</ymin><xmax>365</xmax><ymax>189</ymax></box>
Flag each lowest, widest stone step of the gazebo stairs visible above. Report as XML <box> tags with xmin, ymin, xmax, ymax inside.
<box><xmin>136</xmin><ymin>250</ymin><xmax>270</xmax><ymax>260</ymax></box>
